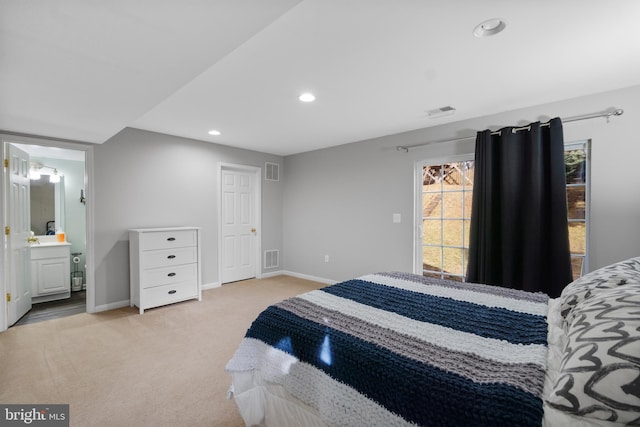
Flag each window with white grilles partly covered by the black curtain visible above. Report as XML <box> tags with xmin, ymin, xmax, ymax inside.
<box><xmin>417</xmin><ymin>141</ymin><xmax>589</xmax><ymax>281</ymax></box>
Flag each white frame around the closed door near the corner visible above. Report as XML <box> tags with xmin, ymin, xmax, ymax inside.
<box><xmin>217</xmin><ymin>162</ymin><xmax>262</xmax><ymax>286</ymax></box>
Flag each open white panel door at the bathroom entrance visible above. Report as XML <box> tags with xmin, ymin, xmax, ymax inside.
<box><xmin>7</xmin><ymin>144</ymin><xmax>31</xmax><ymax>326</ymax></box>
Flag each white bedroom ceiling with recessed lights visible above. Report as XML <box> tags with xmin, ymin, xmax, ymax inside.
<box><xmin>0</xmin><ymin>0</ymin><xmax>640</xmax><ymax>155</ymax></box>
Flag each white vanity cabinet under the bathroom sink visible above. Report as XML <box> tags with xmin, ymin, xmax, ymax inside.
<box><xmin>31</xmin><ymin>243</ymin><xmax>71</xmax><ymax>303</ymax></box>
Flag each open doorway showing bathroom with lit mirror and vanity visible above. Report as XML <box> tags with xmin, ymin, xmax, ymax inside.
<box><xmin>0</xmin><ymin>135</ymin><xmax>95</xmax><ymax>331</ymax></box>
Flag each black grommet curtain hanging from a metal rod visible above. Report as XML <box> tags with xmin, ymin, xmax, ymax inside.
<box><xmin>467</xmin><ymin>118</ymin><xmax>572</xmax><ymax>297</ymax></box>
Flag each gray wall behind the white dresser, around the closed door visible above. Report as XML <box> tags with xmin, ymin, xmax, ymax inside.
<box><xmin>93</xmin><ymin>129</ymin><xmax>283</xmax><ymax>308</ymax></box>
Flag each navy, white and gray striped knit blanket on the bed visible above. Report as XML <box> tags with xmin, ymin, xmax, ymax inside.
<box><xmin>227</xmin><ymin>273</ymin><xmax>548</xmax><ymax>426</ymax></box>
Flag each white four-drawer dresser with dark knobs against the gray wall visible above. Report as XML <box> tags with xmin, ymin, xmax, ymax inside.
<box><xmin>129</xmin><ymin>227</ymin><xmax>202</xmax><ymax>314</ymax></box>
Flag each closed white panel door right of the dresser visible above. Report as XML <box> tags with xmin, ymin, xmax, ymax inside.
<box><xmin>221</xmin><ymin>169</ymin><xmax>257</xmax><ymax>283</ymax></box>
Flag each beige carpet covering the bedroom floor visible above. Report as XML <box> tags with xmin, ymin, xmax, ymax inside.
<box><xmin>0</xmin><ymin>276</ymin><xmax>324</xmax><ymax>426</ymax></box>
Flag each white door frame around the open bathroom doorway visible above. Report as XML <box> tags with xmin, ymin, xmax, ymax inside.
<box><xmin>0</xmin><ymin>133</ymin><xmax>96</xmax><ymax>332</ymax></box>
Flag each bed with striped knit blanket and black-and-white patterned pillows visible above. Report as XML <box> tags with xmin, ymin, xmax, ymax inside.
<box><xmin>226</xmin><ymin>257</ymin><xmax>640</xmax><ymax>427</ymax></box>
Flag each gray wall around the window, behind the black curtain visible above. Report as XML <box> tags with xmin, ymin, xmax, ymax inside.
<box><xmin>283</xmin><ymin>86</ymin><xmax>640</xmax><ymax>280</ymax></box>
